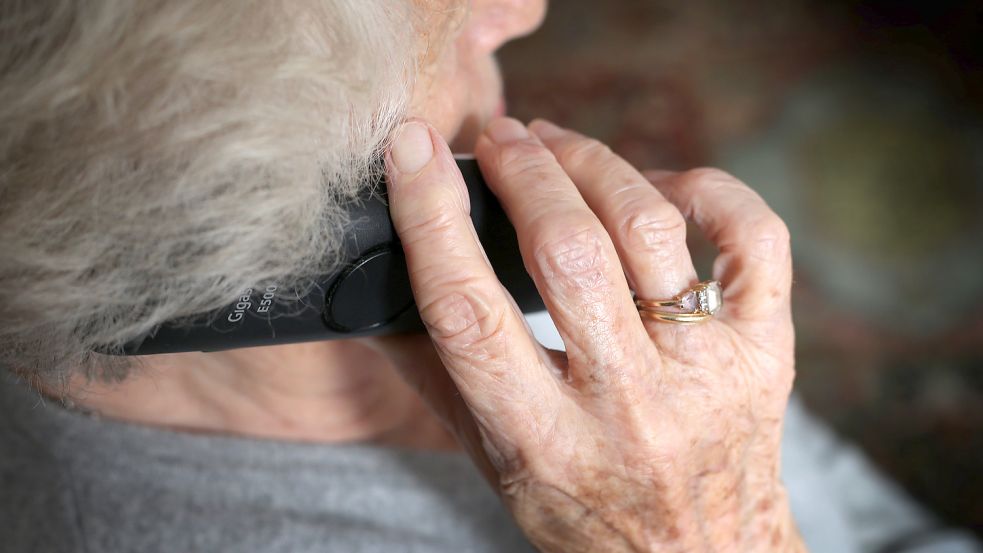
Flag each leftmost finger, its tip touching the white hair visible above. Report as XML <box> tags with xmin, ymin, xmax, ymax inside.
<box><xmin>386</xmin><ymin>120</ymin><xmax>557</xmax><ymax>439</ymax></box>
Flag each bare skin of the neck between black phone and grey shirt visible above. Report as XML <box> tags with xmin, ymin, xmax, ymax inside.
<box><xmin>59</xmin><ymin>341</ymin><xmax>456</xmax><ymax>450</ymax></box>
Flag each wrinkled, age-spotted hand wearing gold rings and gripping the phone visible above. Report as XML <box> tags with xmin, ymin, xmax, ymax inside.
<box><xmin>365</xmin><ymin>114</ymin><xmax>804</xmax><ymax>552</ymax></box>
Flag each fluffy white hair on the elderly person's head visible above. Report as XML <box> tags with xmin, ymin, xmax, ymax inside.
<box><xmin>0</xmin><ymin>0</ymin><xmax>419</xmax><ymax>379</ymax></box>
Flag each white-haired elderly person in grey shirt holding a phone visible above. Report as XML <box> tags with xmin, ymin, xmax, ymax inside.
<box><xmin>0</xmin><ymin>0</ymin><xmax>983</xmax><ymax>552</ymax></box>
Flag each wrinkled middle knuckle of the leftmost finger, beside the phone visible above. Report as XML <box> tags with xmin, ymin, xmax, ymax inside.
<box><xmin>420</xmin><ymin>283</ymin><xmax>506</xmax><ymax>357</ymax></box>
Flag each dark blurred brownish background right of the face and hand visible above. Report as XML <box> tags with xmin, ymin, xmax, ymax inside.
<box><xmin>501</xmin><ymin>0</ymin><xmax>983</xmax><ymax>535</ymax></box>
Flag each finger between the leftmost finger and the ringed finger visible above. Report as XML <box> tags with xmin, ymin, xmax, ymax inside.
<box><xmin>475</xmin><ymin>118</ymin><xmax>649</xmax><ymax>389</ymax></box>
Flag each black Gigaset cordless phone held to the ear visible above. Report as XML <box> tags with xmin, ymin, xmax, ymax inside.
<box><xmin>122</xmin><ymin>157</ymin><xmax>544</xmax><ymax>355</ymax></box>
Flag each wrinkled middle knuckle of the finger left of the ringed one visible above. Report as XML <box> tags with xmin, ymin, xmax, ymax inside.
<box><xmin>533</xmin><ymin>227</ymin><xmax>609</xmax><ymax>291</ymax></box>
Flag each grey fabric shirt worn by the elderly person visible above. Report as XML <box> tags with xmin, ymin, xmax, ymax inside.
<box><xmin>0</xmin><ymin>366</ymin><xmax>979</xmax><ymax>553</ymax></box>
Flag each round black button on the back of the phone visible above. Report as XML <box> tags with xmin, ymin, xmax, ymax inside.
<box><xmin>324</xmin><ymin>244</ymin><xmax>414</xmax><ymax>333</ymax></box>
